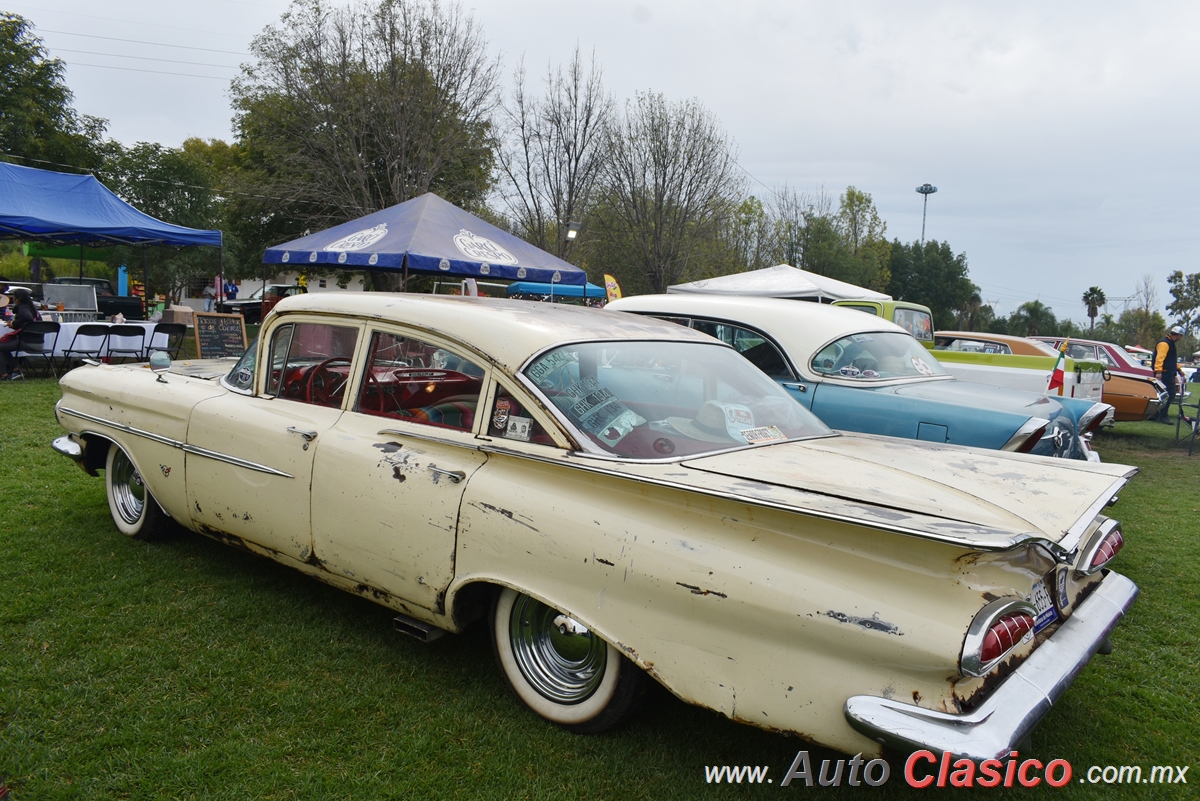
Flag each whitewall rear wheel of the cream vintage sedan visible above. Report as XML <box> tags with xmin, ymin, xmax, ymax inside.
<box><xmin>492</xmin><ymin>589</ymin><xmax>648</xmax><ymax>734</ymax></box>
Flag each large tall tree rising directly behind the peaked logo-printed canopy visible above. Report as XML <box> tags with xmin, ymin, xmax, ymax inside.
<box><xmin>232</xmin><ymin>0</ymin><xmax>499</xmax><ymax>224</ymax></box>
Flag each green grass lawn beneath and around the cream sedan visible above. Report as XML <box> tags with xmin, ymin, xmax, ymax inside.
<box><xmin>0</xmin><ymin>379</ymin><xmax>1200</xmax><ymax>801</ymax></box>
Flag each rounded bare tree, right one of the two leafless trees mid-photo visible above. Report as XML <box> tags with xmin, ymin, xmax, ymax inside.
<box><xmin>601</xmin><ymin>92</ymin><xmax>745</xmax><ymax>293</ymax></box>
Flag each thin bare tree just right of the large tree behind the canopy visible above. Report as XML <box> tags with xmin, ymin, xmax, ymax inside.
<box><xmin>499</xmin><ymin>44</ymin><xmax>613</xmax><ymax>258</ymax></box>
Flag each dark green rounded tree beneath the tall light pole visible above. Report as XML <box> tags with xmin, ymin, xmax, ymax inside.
<box><xmin>887</xmin><ymin>240</ymin><xmax>977</xmax><ymax>329</ymax></box>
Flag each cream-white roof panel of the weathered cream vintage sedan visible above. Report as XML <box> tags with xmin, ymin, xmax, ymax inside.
<box><xmin>275</xmin><ymin>291</ymin><xmax>718</xmax><ymax>369</ymax></box>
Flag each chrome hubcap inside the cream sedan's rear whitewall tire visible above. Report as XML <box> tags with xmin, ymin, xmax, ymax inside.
<box><xmin>509</xmin><ymin>595</ymin><xmax>608</xmax><ymax>704</ymax></box>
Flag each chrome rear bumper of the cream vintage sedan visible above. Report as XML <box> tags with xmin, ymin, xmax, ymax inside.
<box><xmin>844</xmin><ymin>573</ymin><xmax>1138</xmax><ymax>761</ymax></box>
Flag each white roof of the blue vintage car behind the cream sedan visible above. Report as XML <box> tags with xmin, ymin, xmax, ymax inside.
<box><xmin>607</xmin><ymin>294</ymin><xmax>911</xmax><ymax>347</ymax></box>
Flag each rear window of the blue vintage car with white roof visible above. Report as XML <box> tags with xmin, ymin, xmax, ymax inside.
<box><xmin>812</xmin><ymin>331</ymin><xmax>947</xmax><ymax>380</ymax></box>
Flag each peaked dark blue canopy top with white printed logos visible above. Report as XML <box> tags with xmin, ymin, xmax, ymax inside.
<box><xmin>263</xmin><ymin>192</ymin><xmax>587</xmax><ymax>288</ymax></box>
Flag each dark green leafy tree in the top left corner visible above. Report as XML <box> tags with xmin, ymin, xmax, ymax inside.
<box><xmin>0</xmin><ymin>12</ymin><xmax>107</xmax><ymax>170</ymax></box>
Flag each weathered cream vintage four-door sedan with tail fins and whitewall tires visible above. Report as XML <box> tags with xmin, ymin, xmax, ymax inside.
<box><xmin>54</xmin><ymin>294</ymin><xmax>1138</xmax><ymax>759</ymax></box>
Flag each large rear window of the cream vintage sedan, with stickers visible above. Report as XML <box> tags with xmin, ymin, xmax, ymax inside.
<box><xmin>524</xmin><ymin>342</ymin><xmax>832</xmax><ymax>458</ymax></box>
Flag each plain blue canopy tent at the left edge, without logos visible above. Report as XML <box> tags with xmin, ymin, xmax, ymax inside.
<box><xmin>0</xmin><ymin>162</ymin><xmax>224</xmax><ymax>311</ymax></box>
